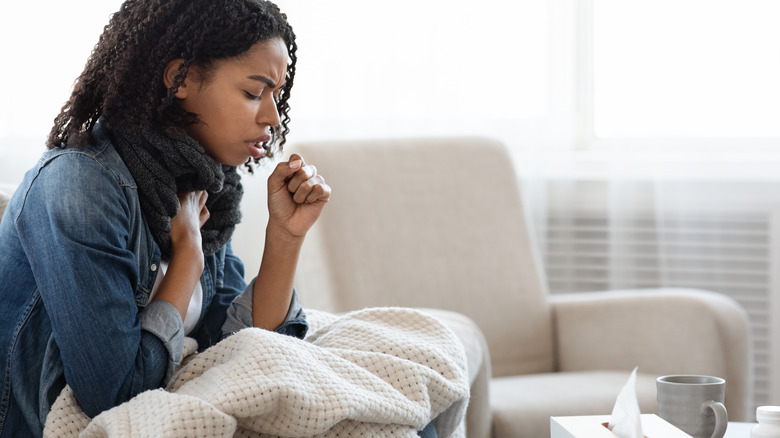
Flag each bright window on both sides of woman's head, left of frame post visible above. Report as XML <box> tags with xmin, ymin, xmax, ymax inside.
<box><xmin>0</xmin><ymin>0</ymin><xmax>552</xmax><ymax>145</ymax></box>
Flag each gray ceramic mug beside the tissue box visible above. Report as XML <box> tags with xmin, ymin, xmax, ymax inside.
<box><xmin>656</xmin><ymin>374</ymin><xmax>729</xmax><ymax>438</ymax></box>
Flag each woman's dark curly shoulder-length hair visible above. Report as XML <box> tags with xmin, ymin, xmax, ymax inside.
<box><xmin>46</xmin><ymin>0</ymin><xmax>297</xmax><ymax>170</ymax></box>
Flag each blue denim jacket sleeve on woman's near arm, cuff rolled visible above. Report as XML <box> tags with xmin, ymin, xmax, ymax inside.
<box><xmin>15</xmin><ymin>152</ymin><xmax>174</xmax><ymax>416</ymax></box>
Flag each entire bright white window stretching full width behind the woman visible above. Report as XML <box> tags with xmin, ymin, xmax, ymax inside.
<box><xmin>0</xmin><ymin>0</ymin><xmax>780</xmax><ymax>150</ymax></box>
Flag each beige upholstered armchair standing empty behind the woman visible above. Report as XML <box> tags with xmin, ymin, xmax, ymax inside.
<box><xmin>289</xmin><ymin>138</ymin><xmax>752</xmax><ymax>438</ymax></box>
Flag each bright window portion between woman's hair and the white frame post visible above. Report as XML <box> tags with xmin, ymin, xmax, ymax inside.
<box><xmin>278</xmin><ymin>0</ymin><xmax>549</xmax><ymax>136</ymax></box>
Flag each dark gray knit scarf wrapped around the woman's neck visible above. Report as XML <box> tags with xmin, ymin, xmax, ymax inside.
<box><xmin>109</xmin><ymin>126</ymin><xmax>244</xmax><ymax>260</ymax></box>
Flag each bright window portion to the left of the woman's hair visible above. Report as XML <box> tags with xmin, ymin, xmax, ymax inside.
<box><xmin>0</xmin><ymin>0</ymin><xmax>122</xmax><ymax>137</ymax></box>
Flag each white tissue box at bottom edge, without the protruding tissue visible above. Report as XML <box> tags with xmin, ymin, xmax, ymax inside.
<box><xmin>550</xmin><ymin>414</ymin><xmax>692</xmax><ymax>438</ymax></box>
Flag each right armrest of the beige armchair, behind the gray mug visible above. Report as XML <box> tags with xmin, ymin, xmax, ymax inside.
<box><xmin>550</xmin><ymin>288</ymin><xmax>753</xmax><ymax>421</ymax></box>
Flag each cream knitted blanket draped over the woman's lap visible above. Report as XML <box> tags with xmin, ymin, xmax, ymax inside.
<box><xmin>44</xmin><ymin>308</ymin><xmax>469</xmax><ymax>437</ymax></box>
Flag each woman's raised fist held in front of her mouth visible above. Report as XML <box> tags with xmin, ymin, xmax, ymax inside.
<box><xmin>268</xmin><ymin>154</ymin><xmax>330</xmax><ymax>238</ymax></box>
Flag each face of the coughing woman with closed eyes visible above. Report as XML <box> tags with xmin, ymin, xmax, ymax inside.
<box><xmin>176</xmin><ymin>38</ymin><xmax>287</xmax><ymax>166</ymax></box>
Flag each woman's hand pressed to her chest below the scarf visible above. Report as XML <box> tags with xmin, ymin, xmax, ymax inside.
<box><xmin>168</xmin><ymin>190</ymin><xmax>209</xmax><ymax>258</ymax></box>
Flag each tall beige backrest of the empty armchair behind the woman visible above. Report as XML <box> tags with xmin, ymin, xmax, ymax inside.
<box><xmin>288</xmin><ymin>138</ymin><xmax>553</xmax><ymax>376</ymax></box>
